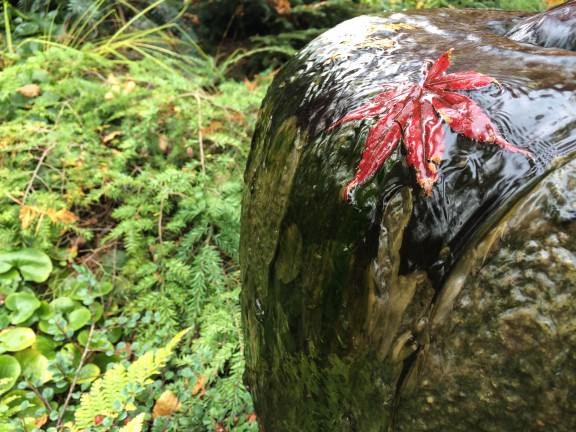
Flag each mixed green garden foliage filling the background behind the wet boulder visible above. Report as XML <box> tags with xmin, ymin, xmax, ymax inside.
<box><xmin>0</xmin><ymin>0</ymin><xmax>544</xmax><ymax>432</ymax></box>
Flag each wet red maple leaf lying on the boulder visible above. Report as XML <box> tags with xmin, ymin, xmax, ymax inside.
<box><xmin>330</xmin><ymin>49</ymin><xmax>531</xmax><ymax>198</ymax></box>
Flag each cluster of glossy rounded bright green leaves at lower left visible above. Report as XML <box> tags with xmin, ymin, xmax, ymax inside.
<box><xmin>0</xmin><ymin>249</ymin><xmax>113</xmax><ymax>430</ymax></box>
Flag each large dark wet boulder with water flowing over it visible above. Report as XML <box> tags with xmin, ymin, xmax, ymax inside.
<box><xmin>241</xmin><ymin>2</ymin><xmax>576</xmax><ymax>432</ymax></box>
